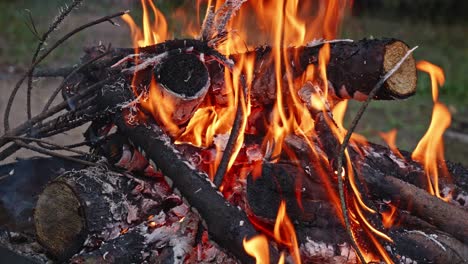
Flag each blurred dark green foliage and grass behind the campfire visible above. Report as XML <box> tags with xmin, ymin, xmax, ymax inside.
<box><xmin>0</xmin><ymin>0</ymin><xmax>468</xmax><ymax>165</ymax></box>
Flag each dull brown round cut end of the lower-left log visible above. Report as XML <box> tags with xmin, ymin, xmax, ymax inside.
<box><xmin>34</xmin><ymin>182</ymin><xmax>86</xmax><ymax>259</ymax></box>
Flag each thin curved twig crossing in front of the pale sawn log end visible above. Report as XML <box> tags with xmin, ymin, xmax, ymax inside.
<box><xmin>336</xmin><ymin>46</ymin><xmax>418</xmax><ymax>263</ymax></box>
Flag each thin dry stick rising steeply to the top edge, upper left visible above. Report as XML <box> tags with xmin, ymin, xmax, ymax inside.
<box><xmin>26</xmin><ymin>0</ymin><xmax>83</xmax><ymax>119</ymax></box>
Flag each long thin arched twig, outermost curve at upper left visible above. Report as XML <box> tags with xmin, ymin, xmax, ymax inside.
<box><xmin>0</xmin><ymin>10</ymin><xmax>129</xmax><ymax>132</ymax></box>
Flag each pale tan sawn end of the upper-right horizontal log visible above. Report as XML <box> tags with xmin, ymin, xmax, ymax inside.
<box><xmin>383</xmin><ymin>41</ymin><xmax>417</xmax><ymax>98</ymax></box>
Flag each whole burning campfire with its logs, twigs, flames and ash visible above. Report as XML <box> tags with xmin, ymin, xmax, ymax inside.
<box><xmin>0</xmin><ymin>0</ymin><xmax>468</xmax><ymax>263</ymax></box>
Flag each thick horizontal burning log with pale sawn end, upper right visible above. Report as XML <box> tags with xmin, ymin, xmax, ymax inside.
<box><xmin>233</xmin><ymin>39</ymin><xmax>417</xmax><ymax>104</ymax></box>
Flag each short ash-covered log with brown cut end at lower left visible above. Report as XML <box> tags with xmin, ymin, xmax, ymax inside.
<box><xmin>34</xmin><ymin>168</ymin><xmax>173</xmax><ymax>260</ymax></box>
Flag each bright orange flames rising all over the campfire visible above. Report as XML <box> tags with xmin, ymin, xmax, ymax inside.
<box><xmin>123</xmin><ymin>0</ymin><xmax>450</xmax><ymax>263</ymax></box>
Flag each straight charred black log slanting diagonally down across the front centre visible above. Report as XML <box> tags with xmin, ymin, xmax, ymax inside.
<box><xmin>111</xmin><ymin>114</ymin><xmax>277</xmax><ymax>263</ymax></box>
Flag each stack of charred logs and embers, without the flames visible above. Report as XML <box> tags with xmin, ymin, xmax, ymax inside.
<box><xmin>1</xmin><ymin>39</ymin><xmax>468</xmax><ymax>263</ymax></box>
